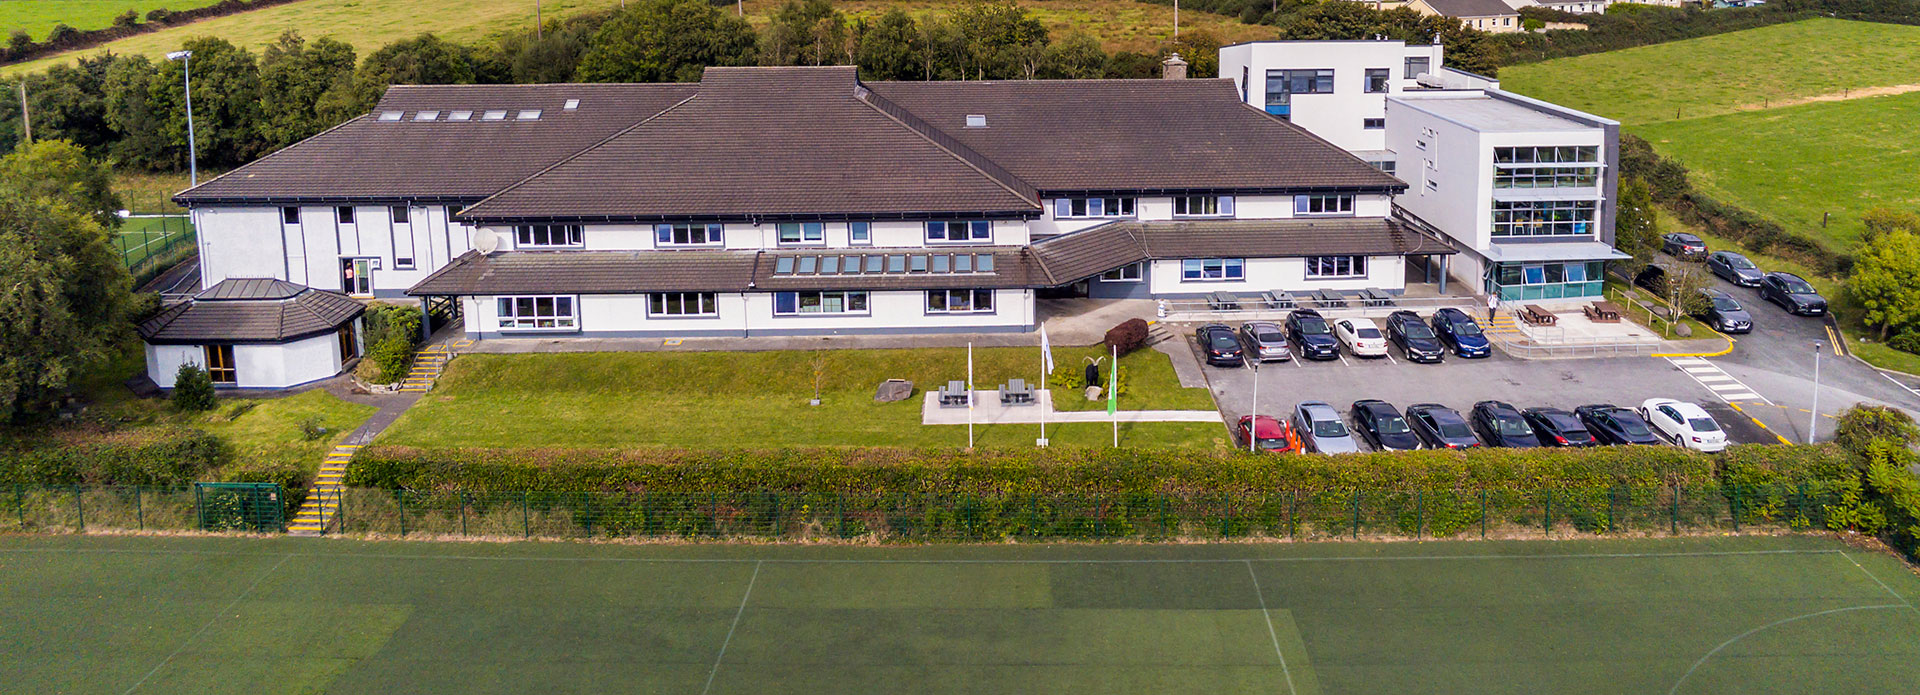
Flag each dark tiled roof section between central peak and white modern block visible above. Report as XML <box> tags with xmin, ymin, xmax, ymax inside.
<box><xmin>868</xmin><ymin>80</ymin><xmax>1405</xmax><ymax>192</ymax></box>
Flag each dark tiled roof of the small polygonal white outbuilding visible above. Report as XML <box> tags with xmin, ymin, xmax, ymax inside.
<box><xmin>138</xmin><ymin>278</ymin><xmax>367</xmax><ymax>346</ymax></box>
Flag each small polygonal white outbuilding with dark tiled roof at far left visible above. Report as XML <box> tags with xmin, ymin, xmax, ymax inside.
<box><xmin>136</xmin><ymin>278</ymin><xmax>367</xmax><ymax>388</ymax></box>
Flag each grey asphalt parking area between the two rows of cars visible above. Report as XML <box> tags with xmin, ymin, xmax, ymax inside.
<box><xmin>1185</xmin><ymin>326</ymin><xmax>1778</xmax><ymax>451</ymax></box>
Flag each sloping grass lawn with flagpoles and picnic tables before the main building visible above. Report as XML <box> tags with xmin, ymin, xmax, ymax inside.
<box><xmin>380</xmin><ymin>348</ymin><xmax>1227</xmax><ymax>449</ymax></box>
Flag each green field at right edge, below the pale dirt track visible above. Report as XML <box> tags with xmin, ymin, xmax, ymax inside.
<box><xmin>1634</xmin><ymin>90</ymin><xmax>1920</xmax><ymax>250</ymax></box>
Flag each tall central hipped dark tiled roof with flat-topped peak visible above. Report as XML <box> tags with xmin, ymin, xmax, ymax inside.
<box><xmin>463</xmin><ymin>67</ymin><xmax>1039</xmax><ymax>221</ymax></box>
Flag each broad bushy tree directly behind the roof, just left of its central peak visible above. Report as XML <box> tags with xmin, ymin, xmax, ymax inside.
<box><xmin>578</xmin><ymin>0</ymin><xmax>755</xmax><ymax>83</ymax></box>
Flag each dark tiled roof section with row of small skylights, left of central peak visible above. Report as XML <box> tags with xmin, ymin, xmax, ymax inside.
<box><xmin>175</xmin><ymin>84</ymin><xmax>697</xmax><ymax>204</ymax></box>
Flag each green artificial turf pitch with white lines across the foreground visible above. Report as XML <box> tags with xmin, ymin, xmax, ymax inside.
<box><xmin>0</xmin><ymin>536</ymin><xmax>1920</xmax><ymax>695</ymax></box>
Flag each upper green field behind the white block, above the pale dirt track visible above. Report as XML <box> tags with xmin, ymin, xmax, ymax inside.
<box><xmin>1500</xmin><ymin>19</ymin><xmax>1920</xmax><ymax>126</ymax></box>
